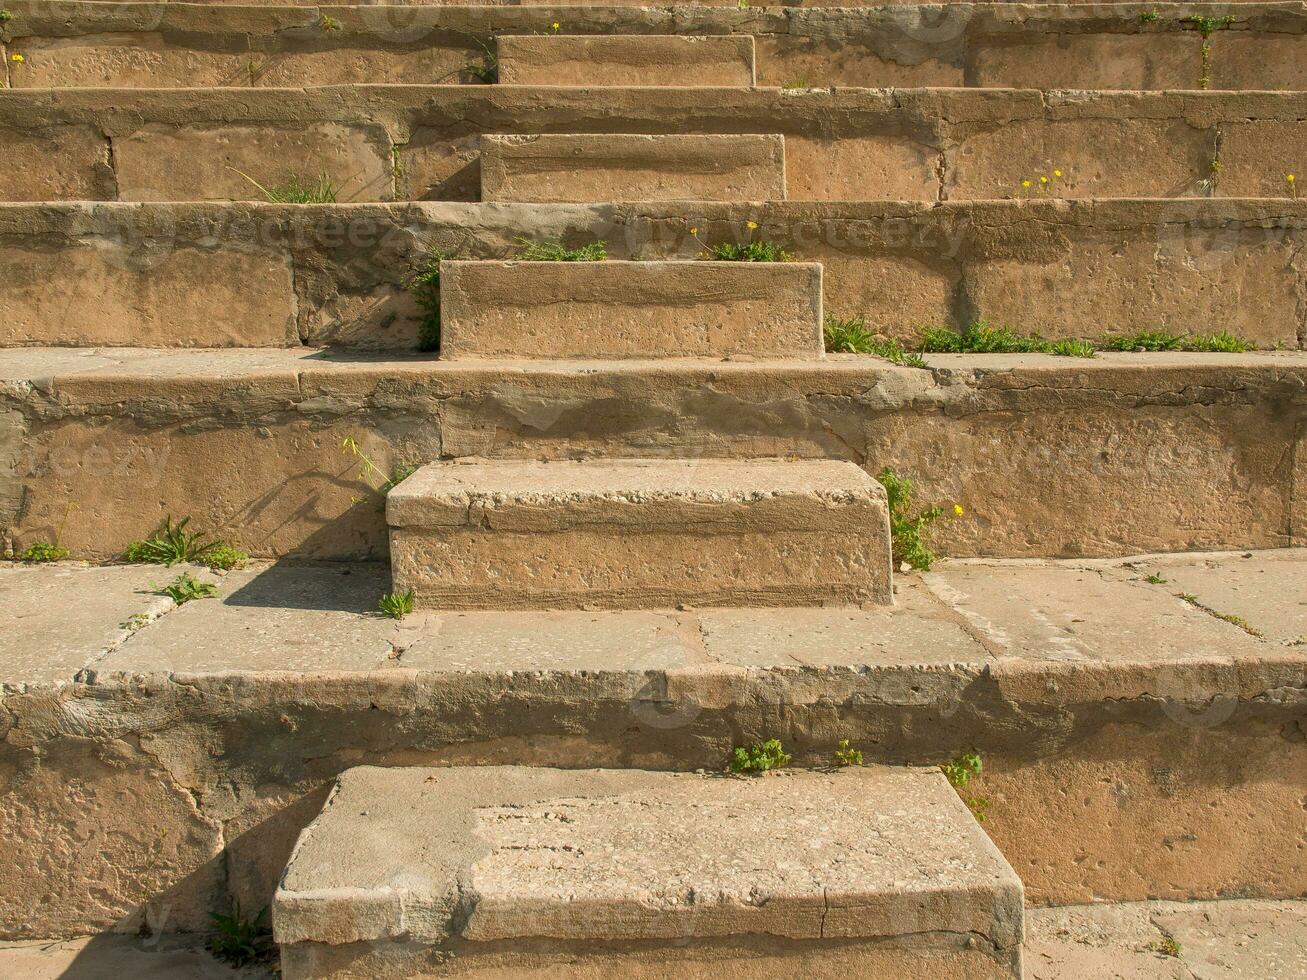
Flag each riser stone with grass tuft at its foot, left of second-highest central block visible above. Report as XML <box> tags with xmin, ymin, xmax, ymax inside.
<box><xmin>114</xmin><ymin>123</ymin><xmax>393</xmax><ymax>203</ymax></box>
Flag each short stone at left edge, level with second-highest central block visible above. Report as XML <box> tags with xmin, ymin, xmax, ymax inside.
<box><xmin>0</xmin><ymin>125</ymin><xmax>115</xmax><ymax>201</ymax></box>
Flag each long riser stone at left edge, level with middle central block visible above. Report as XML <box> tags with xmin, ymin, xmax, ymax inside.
<box><xmin>0</xmin><ymin>245</ymin><xmax>298</xmax><ymax>348</ymax></box>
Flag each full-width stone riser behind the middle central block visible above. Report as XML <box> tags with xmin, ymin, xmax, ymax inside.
<box><xmin>0</xmin><ymin>200</ymin><xmax>1307</xmax><ymax>350</ymax></box>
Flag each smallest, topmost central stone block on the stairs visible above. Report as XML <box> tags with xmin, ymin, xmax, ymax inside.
<box><xmin>497</xmin><ymin>34</ymin><xmax>757</xmax><ymax>88</ymax></box>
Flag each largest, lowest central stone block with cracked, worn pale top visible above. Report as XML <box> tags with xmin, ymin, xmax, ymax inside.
<box><xmin>273</xmin><ymin>766</ymin><xmax>1023</xmax><ymax>980</ymax></box>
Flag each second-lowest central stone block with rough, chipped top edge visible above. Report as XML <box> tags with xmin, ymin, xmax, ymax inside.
<box><xmin>386</xmin><ymin>459</ymin><xmax>893</xmax><ymax>609</ymax></box>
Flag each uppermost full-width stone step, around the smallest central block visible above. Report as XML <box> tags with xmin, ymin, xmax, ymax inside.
<box><xmin>3</xmin><ymin>0</ymin><xmax>1307</xmax><ymax>90</ymax></box>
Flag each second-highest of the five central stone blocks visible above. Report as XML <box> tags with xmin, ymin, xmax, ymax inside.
<box><xmin>481</xmin><ymin>133</ymin><xmax>786</xmax><ymax>204</ymax></box>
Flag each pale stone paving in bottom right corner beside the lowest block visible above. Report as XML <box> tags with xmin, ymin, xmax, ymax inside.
<box><xmin>1026</xmin><ymin>899</ymin><xmax>1307</xmax><ymax>980</ymax></box>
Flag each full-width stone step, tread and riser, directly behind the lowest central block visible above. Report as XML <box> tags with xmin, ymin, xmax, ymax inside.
<box><xmin>0</xmin><ymin>548</ymin><xmax>1307</xmax><ymax>940</ymax></box>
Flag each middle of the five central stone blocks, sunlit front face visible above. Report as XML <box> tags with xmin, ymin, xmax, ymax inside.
<box><xmin>440</xmin><ymin>260</ymin><xmax>823</xmax><ymax>361</ymax></box>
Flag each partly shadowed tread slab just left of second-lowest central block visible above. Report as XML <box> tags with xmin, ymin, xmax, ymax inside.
<box><xmin>89</xmin><ymin>562</ymin><xmax>396</xmax><ymax>678</ymax></box>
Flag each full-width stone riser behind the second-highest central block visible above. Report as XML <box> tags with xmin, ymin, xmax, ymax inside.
<box><xmin>0</xmin><ymin>86</ymin><xmax>1307</xmax><ymax>201</ymax></box>
